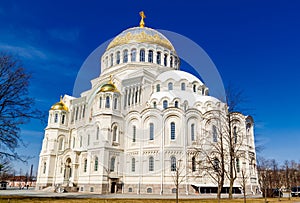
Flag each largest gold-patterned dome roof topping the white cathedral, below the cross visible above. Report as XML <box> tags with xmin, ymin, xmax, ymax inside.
<box><xmin>106</xmin><ymin>27</ymin><xmax>175</xmax><ymax>51</ymax></box>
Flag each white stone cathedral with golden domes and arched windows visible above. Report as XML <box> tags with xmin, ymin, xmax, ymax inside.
<box><xmin>37</xmin><ymin>12</ymin><xmax>258</xmax><ymax>195</ymax></box>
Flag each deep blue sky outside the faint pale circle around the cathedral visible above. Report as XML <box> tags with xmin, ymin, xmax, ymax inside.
<box><xmin>0</xmin><ymin>0</ymin><xmax>300</xmax><ymax>174</ymax></box>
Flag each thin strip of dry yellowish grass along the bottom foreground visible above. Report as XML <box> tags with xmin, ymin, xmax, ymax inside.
<box><xmin>0</xmin><ymin>196</ymin><xmax>300</xmax><ymax>203</ymax></box>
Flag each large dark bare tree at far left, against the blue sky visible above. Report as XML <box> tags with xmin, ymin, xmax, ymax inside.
<box><xmin>0</xmin><ymin>53</ymin><xmax>42</xmax><ymax>161</ymax></box>
